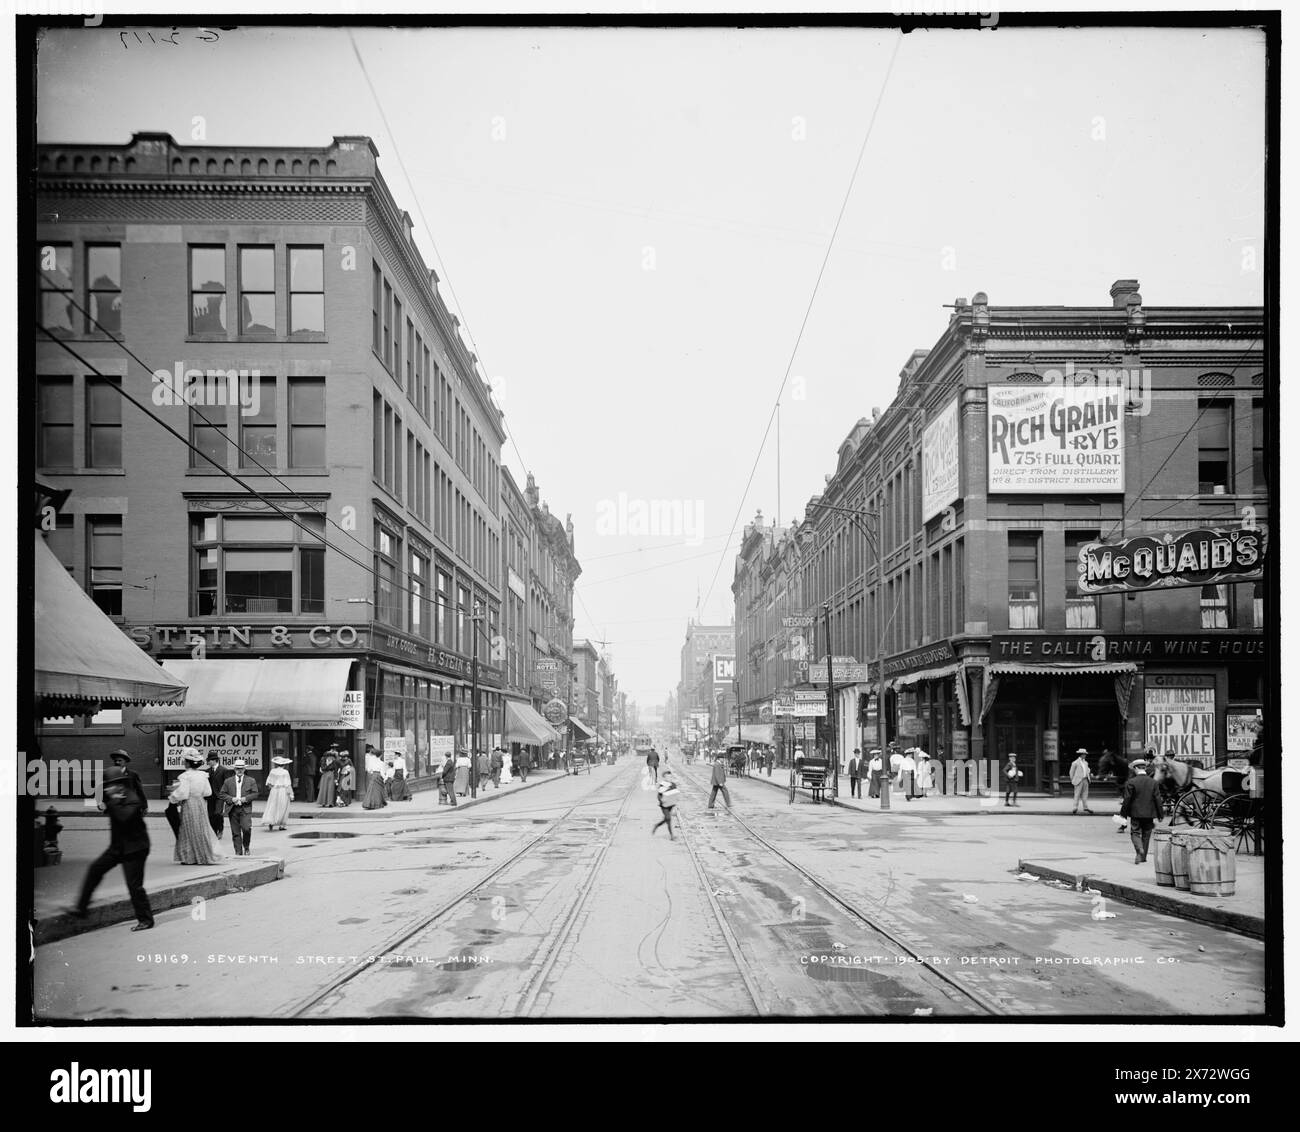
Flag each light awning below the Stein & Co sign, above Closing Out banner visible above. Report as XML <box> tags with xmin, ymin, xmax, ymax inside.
<box><xmin>137</xmin><ymin>656</ymin><xmax>352</xmax><ymax>730</ymax></box>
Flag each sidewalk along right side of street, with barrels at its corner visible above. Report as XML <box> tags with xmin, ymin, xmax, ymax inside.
<box><xmin>729</xmin><ymin>768</ymin><xmax>1264</xmax><ymax>938</ymax></box>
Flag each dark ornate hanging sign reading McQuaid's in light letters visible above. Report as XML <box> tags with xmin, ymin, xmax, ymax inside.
<box><xmin>1079</xmin><ymin>526</ymin><xmax>1269</xmax><ymax>594</ymax></box>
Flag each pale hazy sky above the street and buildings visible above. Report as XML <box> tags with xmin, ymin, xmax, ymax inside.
<box><xmin>36</xmin><ymin>19</ymin><xmax>1265</xmax><ymax>706</ymax></box>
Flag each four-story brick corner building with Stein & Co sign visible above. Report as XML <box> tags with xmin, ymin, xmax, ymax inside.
<box><xmin>34</xmin><ymin>134</ymin><xmax>504</xmax><ymax>798</ymax></box>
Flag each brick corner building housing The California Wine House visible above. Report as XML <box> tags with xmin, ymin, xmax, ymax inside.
<box><xmin>737</xmin><ymin>279</ymin><xmax>1271</xmax><ymax>789</ymax></box>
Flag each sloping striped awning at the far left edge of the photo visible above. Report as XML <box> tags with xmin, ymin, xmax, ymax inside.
<box><xmin>35</xmin><ymin>537</ymin><xmax>186</xmax><ymax>716</ymax></box>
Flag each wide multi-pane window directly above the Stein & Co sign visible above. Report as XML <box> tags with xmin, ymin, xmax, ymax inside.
<box><xmin>190</xmin><ymin>513</ymin><xmax>325</xmax><ymax>617</ymax></box>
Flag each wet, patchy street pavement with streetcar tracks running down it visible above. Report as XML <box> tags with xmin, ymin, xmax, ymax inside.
<box><xmin>35</xmin><ymin>762</ymin><xmax>1264</xmax><ymax>1022</ymax></box>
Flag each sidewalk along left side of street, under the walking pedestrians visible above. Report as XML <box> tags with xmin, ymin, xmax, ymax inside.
<box><xmin>33</xmin><ymin>767</ymin><xmax>579</xmax><ymax>946</ymax></box>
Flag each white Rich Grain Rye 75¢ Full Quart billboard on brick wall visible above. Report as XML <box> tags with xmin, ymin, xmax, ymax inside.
<box><xmin>985</xmin><ymin>385</ymin><xmax>1125</xmax><ymax>495</ymax></box>
